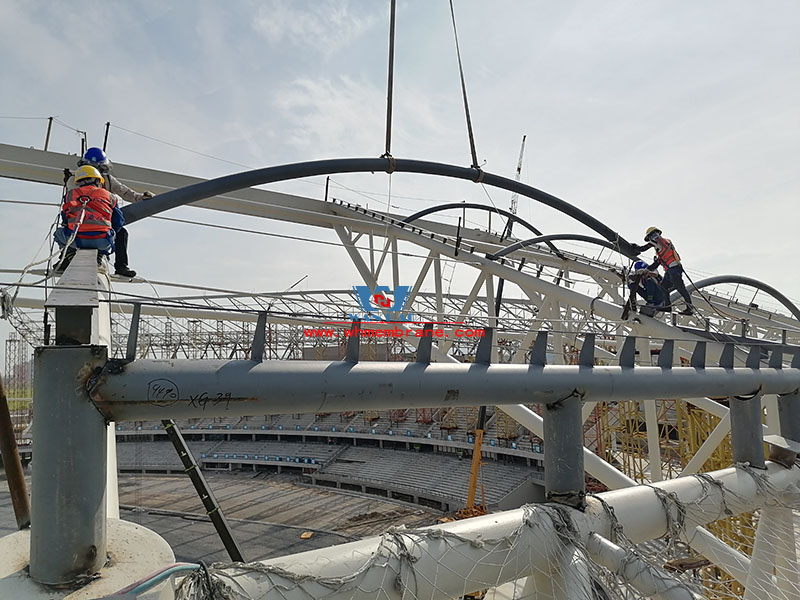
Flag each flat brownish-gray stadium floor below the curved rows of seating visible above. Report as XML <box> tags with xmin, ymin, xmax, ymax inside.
<box><xmin>0</xmin><ymin>473</ymin><xmax>441</xmax><ymax>564</ymax></box>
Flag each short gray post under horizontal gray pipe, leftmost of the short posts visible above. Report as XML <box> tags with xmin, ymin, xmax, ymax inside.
<box><xmin>542</xmin><ymin>394</ymin><xmax>586</xmax><ymax>508</ymax></box>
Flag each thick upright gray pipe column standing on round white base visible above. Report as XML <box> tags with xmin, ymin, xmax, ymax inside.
<box><xmin>30</xmin><ymin>346</ymin><xmax>107</xmax><ymax>585</ymax></box>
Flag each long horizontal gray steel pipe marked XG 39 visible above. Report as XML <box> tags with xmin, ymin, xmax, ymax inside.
<box><xmin>86</xmin><ymin>360</ymin><xmax>800</xmax><ymax>421</ymax></box>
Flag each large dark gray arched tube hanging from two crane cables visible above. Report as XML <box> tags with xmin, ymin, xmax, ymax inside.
<box><xmin>122</xmin><ymin>158</ymin><xmax>638</xmax><ymax>258</ymax></box>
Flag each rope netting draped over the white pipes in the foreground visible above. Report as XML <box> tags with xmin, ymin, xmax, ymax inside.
<box><xmin>176</xmin><ymin>465</ymin><xmax>800</xmax><ymax>600</ymax></box>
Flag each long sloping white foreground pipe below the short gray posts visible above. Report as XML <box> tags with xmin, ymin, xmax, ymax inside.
<box><xmin>198</xmin><ymin>462</ymin><xmax>800</xmax><ymax>600</ymax></box>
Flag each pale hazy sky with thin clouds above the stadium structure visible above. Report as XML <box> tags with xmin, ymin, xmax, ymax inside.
<box><xmin>0</xmin><ymin>0</ymin><xmax>800</xmax><ymax>366</ymax></box>
